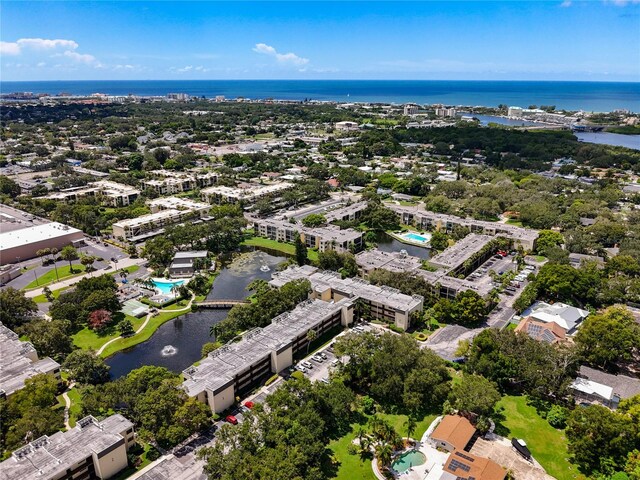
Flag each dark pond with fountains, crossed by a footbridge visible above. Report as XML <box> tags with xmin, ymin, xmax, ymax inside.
<box><xmin>106</xmin><ymin>250</ymin><xmax>286</xmax><ymax>378</ymax></box>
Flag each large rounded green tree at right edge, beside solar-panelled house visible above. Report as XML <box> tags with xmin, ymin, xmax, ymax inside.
<box><xmin>575</xmin><ymin>306</ymin><xmax>640</xmax><ymax>368</ymax></box>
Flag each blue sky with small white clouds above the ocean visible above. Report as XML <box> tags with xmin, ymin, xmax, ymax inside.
<box><xmin>0</xmin><ymin>0</ymin><xmax>640</xmax><ymax>81</ymax></box>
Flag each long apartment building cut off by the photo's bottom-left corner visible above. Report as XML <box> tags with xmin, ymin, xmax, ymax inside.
<box><xmin>0</xmin><ymin>415</ymin><xmax>135</xmax><ymax>480</ymax></box>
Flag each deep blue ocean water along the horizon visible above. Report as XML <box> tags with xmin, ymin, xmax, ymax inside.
<box><xmin>0</xmin><ymin>80</ymin><xmax>640</xmax><ymax>112</ymax></box>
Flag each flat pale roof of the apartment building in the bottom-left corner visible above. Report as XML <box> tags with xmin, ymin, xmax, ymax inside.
<box><xmin>0</xmin><ymin>414</ymin><xmax>133</xmax><ymax>480</ymax></box>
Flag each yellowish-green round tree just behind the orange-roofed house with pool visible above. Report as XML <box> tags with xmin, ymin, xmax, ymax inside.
<box><xmin>450</xmin><ymin>374</ymin><xmax>500</xmax><ymax>415</ymax></box>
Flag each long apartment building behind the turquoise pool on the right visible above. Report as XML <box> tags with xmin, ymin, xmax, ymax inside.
<box><xmin>389</xmin><ymin>205</ymin><xmax>538</xmax><ymax>251</ymax></box>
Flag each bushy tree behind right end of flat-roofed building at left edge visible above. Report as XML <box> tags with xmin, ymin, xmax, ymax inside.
<box><xmin>21</xmin><ymin>319</ymin><xmax>73</xmax><ymax>362</ymax></box>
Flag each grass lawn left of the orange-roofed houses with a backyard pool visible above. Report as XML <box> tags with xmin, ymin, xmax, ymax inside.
<box><xmin>329</xmin><ymin>413</ymin><xmax>437</xmax><ymax>480</ymax></box>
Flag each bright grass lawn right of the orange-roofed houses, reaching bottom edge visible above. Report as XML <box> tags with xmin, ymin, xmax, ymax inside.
<box><xmin>494</xmin><ymin>395</ymin><xmax>583</xmax><ymax>480</ymax></box>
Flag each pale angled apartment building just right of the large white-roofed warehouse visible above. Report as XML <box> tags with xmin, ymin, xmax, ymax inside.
<box><xmin>113</xmin><ymin>197</ymin><xmax>211</xmax><ymax>242</ymax></box>
